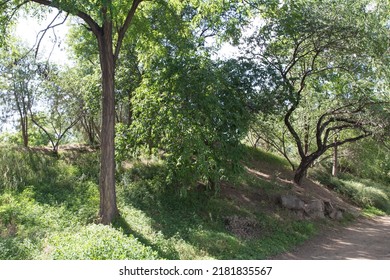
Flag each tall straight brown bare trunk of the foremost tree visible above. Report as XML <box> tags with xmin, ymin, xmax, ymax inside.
<box><xmin>98</xmin><ymin>22</ymin><xmax>119</xmax><ymax>224</ymax></box>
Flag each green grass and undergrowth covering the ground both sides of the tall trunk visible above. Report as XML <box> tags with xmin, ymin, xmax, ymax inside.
<box><xmin>0</xmin><ymin>148</ymin><xmax>317</xmax><ymax>259</ymax></box>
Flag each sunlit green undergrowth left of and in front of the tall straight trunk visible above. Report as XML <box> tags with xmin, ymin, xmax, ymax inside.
<box><xmin>0</xmin><ymin>149</ymin><xmax>156</xmax><ymax>259</ymax></box>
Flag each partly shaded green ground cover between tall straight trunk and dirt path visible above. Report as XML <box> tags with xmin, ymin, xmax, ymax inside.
<box><xmin>118</xmin><ymin>155</ymin><xmax>316</xmax><ymax>259</ymax></box>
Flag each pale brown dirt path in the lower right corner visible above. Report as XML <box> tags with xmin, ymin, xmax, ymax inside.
<box><xmin>272</xmin><ymin>216</ymin><xmax>390</xmax><ymax>260</ymax></box>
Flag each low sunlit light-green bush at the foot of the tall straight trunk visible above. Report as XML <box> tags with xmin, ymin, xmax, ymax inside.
<box><xmin>45</xmin><ymin>225</ymin><xmax>157</xmax><ymax>260</ymax></box>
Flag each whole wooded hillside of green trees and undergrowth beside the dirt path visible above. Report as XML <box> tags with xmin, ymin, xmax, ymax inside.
<box><xmin>0</xmin><ymin>0</ymin><xmax>390</xmax><ymax>260</ymax></box>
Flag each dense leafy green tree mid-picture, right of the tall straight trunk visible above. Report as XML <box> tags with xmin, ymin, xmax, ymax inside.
<box><xmin>111</xmin><ymin>2</ymin><xmax>253</xmax><ymax>190</ymax></box>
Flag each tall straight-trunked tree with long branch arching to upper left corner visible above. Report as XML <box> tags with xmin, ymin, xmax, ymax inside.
<box><xmin>0</xmin><ymin>0</ymin><xmax>142</xmax><ymax>224</ymax></box>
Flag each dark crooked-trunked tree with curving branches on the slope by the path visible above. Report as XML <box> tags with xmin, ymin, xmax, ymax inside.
<box><xmin>245</xmin><ymin>1</ymin><xmax>388</xmax><ymax>184</ymax></box>
